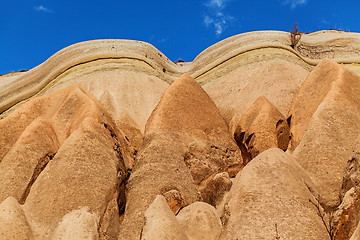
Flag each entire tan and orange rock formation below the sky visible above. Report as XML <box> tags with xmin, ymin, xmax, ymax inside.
<box><xmin>0</xmin><ymin>31</ymin><xmax>360</xmax><ymax>240</ymax></box>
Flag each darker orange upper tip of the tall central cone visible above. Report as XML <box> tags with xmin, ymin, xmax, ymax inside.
<box><xmin>146</xmin><ymin>74</ymin><xmax>233</xmax><ymax>142</ymax></box>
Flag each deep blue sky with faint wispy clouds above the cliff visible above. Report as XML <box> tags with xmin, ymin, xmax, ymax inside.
<box><xmin>0</xmin><ymin>0</ymin><xmax>360</xmax><ymax>74</ymax></box>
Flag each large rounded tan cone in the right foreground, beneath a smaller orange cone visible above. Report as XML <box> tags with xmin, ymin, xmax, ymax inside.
<box><xmin>221</xmin><ymin>148</ymin><xmax>328</xmax><ymax>239</ymax></box>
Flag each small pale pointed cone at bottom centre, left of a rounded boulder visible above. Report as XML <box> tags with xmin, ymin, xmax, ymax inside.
<box><xmin>140</xmin><ymin>195</ymin><xmax>189</xmax><ymax>240</ymax></box>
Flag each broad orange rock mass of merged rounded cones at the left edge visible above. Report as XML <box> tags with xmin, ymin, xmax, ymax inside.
<box><xmin>0</xmin><ymin>86</ymin><xmax>131</xmax><ymax>239</ymax></box>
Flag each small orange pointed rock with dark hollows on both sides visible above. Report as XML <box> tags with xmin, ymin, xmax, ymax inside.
<box><xmin>231</xmin><ymin>96</ymin><xmax>290</xmax><ymax>163</ymax></box>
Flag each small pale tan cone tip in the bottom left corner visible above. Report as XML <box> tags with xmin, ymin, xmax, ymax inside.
<box><xmin>0</xmin><ymin>197</ymin><xmax>34</xmax><ymax>240</ymax></box>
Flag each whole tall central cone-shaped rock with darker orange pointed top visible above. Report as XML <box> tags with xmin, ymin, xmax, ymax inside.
<box><xmin>119</xmin><ymin>74</ymin><xmax>242</xmax><ymax>239</ymax></box>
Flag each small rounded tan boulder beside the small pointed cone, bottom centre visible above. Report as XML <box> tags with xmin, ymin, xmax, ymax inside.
<box><xmin>176</xmin><ymin>202</ymin><xmax>222</xmax><ymax>240</ymax></box>
